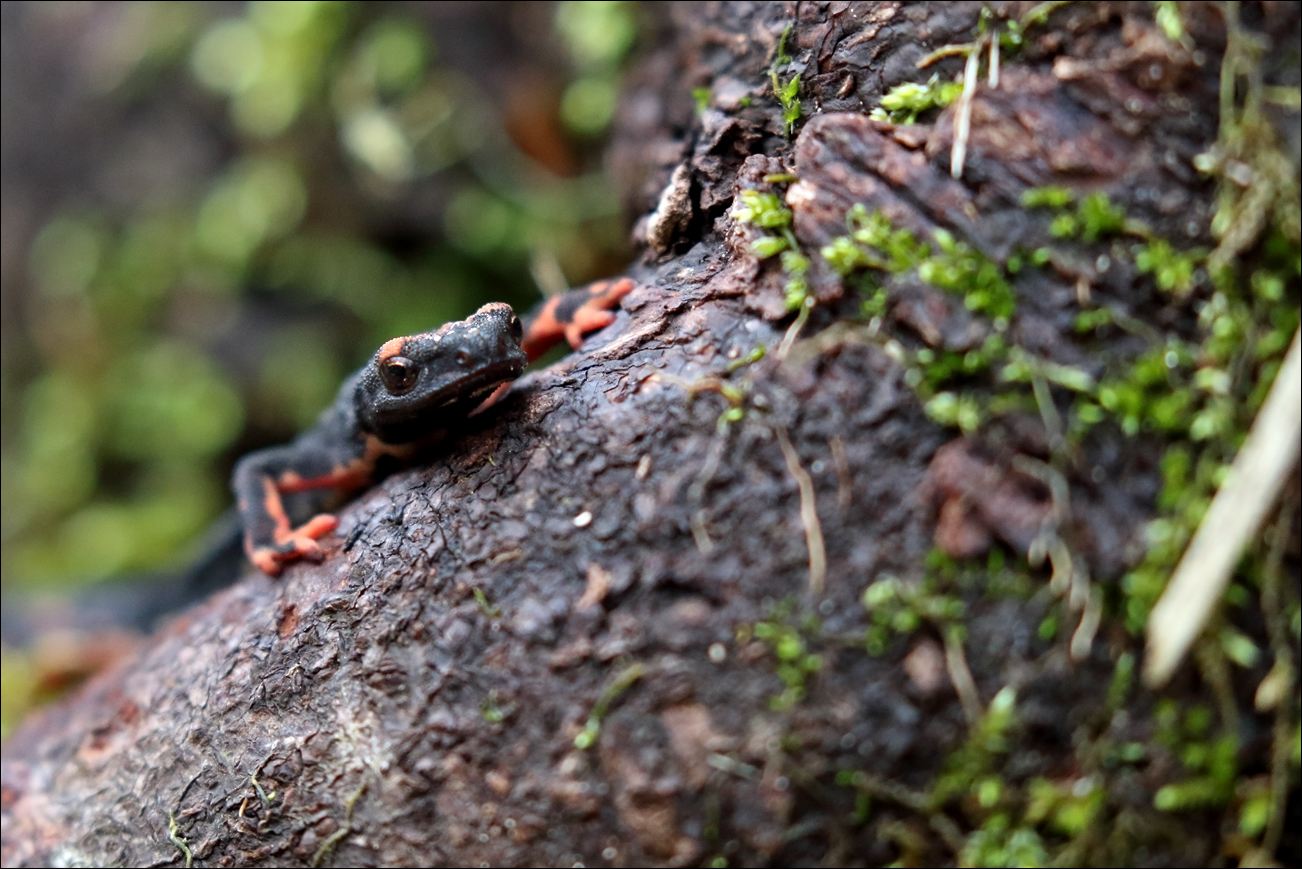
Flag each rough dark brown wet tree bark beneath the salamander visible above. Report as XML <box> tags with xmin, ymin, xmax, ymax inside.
<box><xmin>3</xmin><ymin>3</ymin><xmax>1295</xmax><ymax>865</ymax></box>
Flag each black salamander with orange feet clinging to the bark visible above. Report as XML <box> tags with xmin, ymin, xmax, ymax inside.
<box><xmin>240</xmin><ymin>278</ymin><xmax>634</xmax><ymax>576</ymax></box>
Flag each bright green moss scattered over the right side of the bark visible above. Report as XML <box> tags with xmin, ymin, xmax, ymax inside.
<box><xmin>769</xmin><ymin>10</ymin><xmax>1302</xmax><ymax>865</ymax></box>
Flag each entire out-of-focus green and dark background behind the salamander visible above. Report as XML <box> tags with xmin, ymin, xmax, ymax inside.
<box><xmin>0</xmin><ymin>0</ymin><xmax>655</xmax><ymax>732</ymax></box>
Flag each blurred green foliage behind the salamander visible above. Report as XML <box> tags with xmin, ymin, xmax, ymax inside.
<box><xmin>3</xmin><ymin>1</ymin><xmax>639</xmax><ymax>586</ymax></box>
